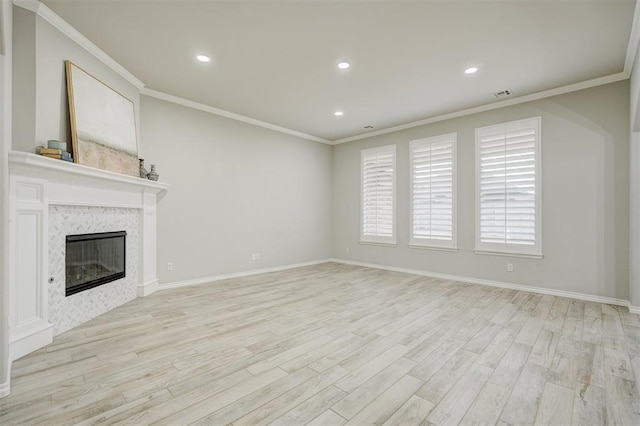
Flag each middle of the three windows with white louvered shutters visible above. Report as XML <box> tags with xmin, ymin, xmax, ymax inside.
<box><xmin>409</xmin><ymin>133</ymin><xmax>456</xmax><ymax>249</ymax></box>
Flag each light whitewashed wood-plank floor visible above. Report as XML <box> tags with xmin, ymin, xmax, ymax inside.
<box><xmin>0</xmin><ymin>263</ymin><xmax>640</xmax><ymax>425</ymax></box>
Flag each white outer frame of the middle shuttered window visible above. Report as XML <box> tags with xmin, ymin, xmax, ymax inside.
<box><xmin>409</xmin><ymin>132</ymin><xmax>458</xmax><ymax>251</ymax></box>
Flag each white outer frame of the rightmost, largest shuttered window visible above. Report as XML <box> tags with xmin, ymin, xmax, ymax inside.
<box><xmin>474</xmin><ymin>116</ymin><xmax>543</xmax><ymax>259</ymax></box>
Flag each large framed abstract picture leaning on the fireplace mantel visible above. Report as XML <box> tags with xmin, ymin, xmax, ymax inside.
<box><xmin>65</xmin><ymin>61</ymin><xmax>140</xmax><ymax>176</ymax></box>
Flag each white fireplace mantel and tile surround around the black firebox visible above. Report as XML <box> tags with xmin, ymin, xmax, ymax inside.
<box><xmin>9</xmin><ymin>152</ymin><xmax>168</xmax><ymax>360</ymax></box>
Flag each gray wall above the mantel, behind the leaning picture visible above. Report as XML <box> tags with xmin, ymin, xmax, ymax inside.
<box><xmin>13</xmin><ymin>7</ymin><xmax>140</xmax><ymax>152</ymax></box>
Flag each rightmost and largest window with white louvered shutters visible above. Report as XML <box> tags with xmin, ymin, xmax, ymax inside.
<box><xmin>476</xmin><ymin>117</ymin><xmax>542</xmax><ymax>257</ymax></box>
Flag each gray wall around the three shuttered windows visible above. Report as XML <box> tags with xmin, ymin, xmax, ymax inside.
<box><xmin>333</xmin><ymin>81</ymin><xmax>629</xmax><ymax>299</ymax></box>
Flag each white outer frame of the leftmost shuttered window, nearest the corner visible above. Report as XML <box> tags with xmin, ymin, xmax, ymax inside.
<box><xmin>359</xmin><ymin>144</ymin><xmax>397</xmax><ymax>247</ymax></box>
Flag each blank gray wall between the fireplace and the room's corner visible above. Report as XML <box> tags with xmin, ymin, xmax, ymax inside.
<box><xmin>140</xmin><ymin>96</ymin><xmax>332</xmax><ymax>283</ymax></box>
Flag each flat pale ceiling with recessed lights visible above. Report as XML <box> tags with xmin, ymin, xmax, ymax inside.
<box><xmin>43</xmin><ymin>0</ymin><xmax>635</xmax><ymax>141</ymax></box>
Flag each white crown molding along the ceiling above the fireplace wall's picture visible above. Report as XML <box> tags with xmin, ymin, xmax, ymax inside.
<box><xmin>13</xmin><ymin>0</ymin><xmax>144</xmax><ymax>90</ymax></box>
